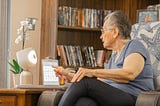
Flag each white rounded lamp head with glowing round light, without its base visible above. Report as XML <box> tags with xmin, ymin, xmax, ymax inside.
<box><xmin>16</xmin><ymin>48</ymin><xmax>37</xmax><ymax>70</ymax></box>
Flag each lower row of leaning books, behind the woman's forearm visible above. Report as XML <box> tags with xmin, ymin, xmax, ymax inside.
<box><xmin>57</xmin><ymin>45</ymin><xmax>107</xmax><ymax>68</ymax></box>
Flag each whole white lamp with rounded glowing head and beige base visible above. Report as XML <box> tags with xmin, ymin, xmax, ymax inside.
<box><xmin>16</xmin><ymin>48</ymin><xmax>37</xmax><ymax>85</ymax></box>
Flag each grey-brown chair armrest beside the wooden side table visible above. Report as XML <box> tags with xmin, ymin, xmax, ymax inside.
<box><xmin>37</xmin><ymin>90</ymin><xmax>65</xmax><ymax>106</ymax></box>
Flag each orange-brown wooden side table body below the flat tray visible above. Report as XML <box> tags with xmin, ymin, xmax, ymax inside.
<box><xmin>0</xmin><ymin>89</ymin><xmax>42</xmax><ymax>106</ymax></box>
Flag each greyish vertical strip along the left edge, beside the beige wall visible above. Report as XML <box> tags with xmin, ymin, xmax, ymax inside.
<box><xmin>0</xmin><ymin>0</ymin><xmax>9</xmax><ymax>88</ymax></box>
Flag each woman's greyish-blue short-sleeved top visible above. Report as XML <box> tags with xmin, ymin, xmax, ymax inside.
<box><xmin>104</xmin><ymin>40</ymin><xmax>154</xmax><ymax>96</ymax></box>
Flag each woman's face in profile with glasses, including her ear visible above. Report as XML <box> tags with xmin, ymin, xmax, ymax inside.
<box><xmin>100</xmin><ymin>22</ymin><xmax>115</xmax><ymax>49</ymax></box>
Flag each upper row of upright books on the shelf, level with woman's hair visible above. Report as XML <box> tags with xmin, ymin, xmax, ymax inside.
<box><xmin>58</xmin><ymin>6</ymin><xmax>113</xmax><ymax>28</ymax></box>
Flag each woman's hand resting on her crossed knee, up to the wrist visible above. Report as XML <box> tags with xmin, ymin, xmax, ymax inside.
<box><xmin>71</xmin><ymin>68</ymin><xmax>94</xmax><ymax>82</ymax></box>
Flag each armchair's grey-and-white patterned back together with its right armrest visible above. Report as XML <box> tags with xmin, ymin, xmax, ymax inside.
<box><xmin>131</xmin><ymin>21</ymin><xmax>160</xmax><ymax>106</ymax></box>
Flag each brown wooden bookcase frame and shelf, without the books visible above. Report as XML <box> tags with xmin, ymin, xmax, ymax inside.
<box><xmin>40</xmin><ymin>0</ymin><xmax>159</xmax><ymax>82</ymax></box>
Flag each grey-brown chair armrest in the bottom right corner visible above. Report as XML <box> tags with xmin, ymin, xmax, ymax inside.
<box><xmin>135</xmin><ymin>91</ymin><xmax>160</xmax><ymax>106</ymax></box>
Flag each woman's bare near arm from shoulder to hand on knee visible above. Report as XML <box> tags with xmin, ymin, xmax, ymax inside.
<box><xmin>72</xmin><ymin>53</ymin><xmax>144</xmax><ymax>83</ymax></box>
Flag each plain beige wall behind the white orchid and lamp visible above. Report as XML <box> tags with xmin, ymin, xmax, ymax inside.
<box><xmin>9</xmin><ymin>0</ymin><xmax>41</xmax><ymax>87</ymax></box>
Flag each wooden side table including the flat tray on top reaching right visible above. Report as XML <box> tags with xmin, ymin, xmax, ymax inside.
<box><xmin>0</xmin><ymin>85</ymin><xmax>67</xmax><ymax>106</ymax></box>
